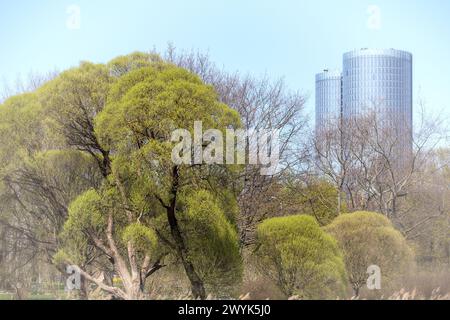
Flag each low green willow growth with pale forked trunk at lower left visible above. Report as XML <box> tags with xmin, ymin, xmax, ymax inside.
<box><xmin>54</xmin><ymin>189</ymin><xmax>161</xmax><ymax>299</ymax></box>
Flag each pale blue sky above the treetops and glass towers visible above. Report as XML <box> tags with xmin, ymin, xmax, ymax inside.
<box><xmin>0</xmin><ymin>0</ymin><xmax>450</xmax><ymax>119</ymax></box>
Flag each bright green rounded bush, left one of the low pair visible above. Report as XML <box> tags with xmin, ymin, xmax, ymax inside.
<box><xmin>256</xmin><ymin>215</ymin><xmax>346</xmax><ymax>299</ymax></box>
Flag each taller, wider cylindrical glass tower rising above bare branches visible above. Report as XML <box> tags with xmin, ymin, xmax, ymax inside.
<box><xmin>342</xmin><ymin>49</ymin><xmax>412</xmax><ymax>154</ymax></box>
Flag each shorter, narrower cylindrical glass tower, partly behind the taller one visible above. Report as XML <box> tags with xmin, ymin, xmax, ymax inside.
<box><xmin>316</xmin><ymin>70</ymin><xmax>342</xmax><ymax>133</ymax></box>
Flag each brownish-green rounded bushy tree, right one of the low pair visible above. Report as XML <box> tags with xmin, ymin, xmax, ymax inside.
<box><xmin>325</xmin><ymin>211</ymin><xmax>413</xmax><ymax>296</ymax></box>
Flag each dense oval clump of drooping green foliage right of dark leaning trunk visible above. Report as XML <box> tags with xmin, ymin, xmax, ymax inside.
<box><xmin>182</xmin><ymin>190</ymin><xmax>242</xmax><ymax>293</ymax></box>
